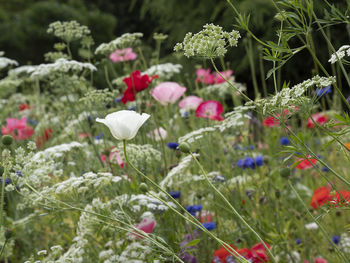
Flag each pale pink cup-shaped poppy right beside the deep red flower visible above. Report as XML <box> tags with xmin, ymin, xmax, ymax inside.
<box><xmin>151</xmin><ymin>82</ymin><xmax>186</xmax><ymax>106</ymax></box>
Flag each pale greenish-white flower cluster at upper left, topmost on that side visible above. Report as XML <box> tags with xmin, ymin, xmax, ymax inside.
<box><xmin>47</xmin><ymin>21</ymin><xmax>90</xmax><ymax>43</ymax></box>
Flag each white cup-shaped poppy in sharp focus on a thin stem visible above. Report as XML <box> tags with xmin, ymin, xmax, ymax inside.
<box><xmin>96</xmin><ymin>110</ymin><xmax>150</xmax><ymax>140</ymax></box>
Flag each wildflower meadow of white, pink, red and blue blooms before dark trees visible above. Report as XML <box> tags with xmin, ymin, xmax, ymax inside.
<box><xmin>0</xmin><ymin>0</ymin><xmax>350</xmax><ymax>263</ymax></box>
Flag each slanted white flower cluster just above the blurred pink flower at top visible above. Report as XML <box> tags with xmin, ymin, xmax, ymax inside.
<box><xmin>95</xmin><ymin>33</ymin><xmax>143</xmax><ymax>55</ymax></box>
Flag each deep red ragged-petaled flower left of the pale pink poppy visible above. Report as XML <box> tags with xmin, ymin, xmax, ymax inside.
<box><xmin>121</xmin><ymin>70</ymin><xmax>158</xmax><ymax>104</ymax></box>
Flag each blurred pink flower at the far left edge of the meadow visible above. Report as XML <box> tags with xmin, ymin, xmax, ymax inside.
<box><xmin>1</xmin><ymin>117</ymin><xmax>34</xmax><ymax>140</ymax></box>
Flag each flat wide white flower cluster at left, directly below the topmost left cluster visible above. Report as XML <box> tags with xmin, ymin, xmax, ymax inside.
<box><xmin>30</xmin><ymin>58</ymin><xmax>97</xmax><ymax>79</ymax></box>
